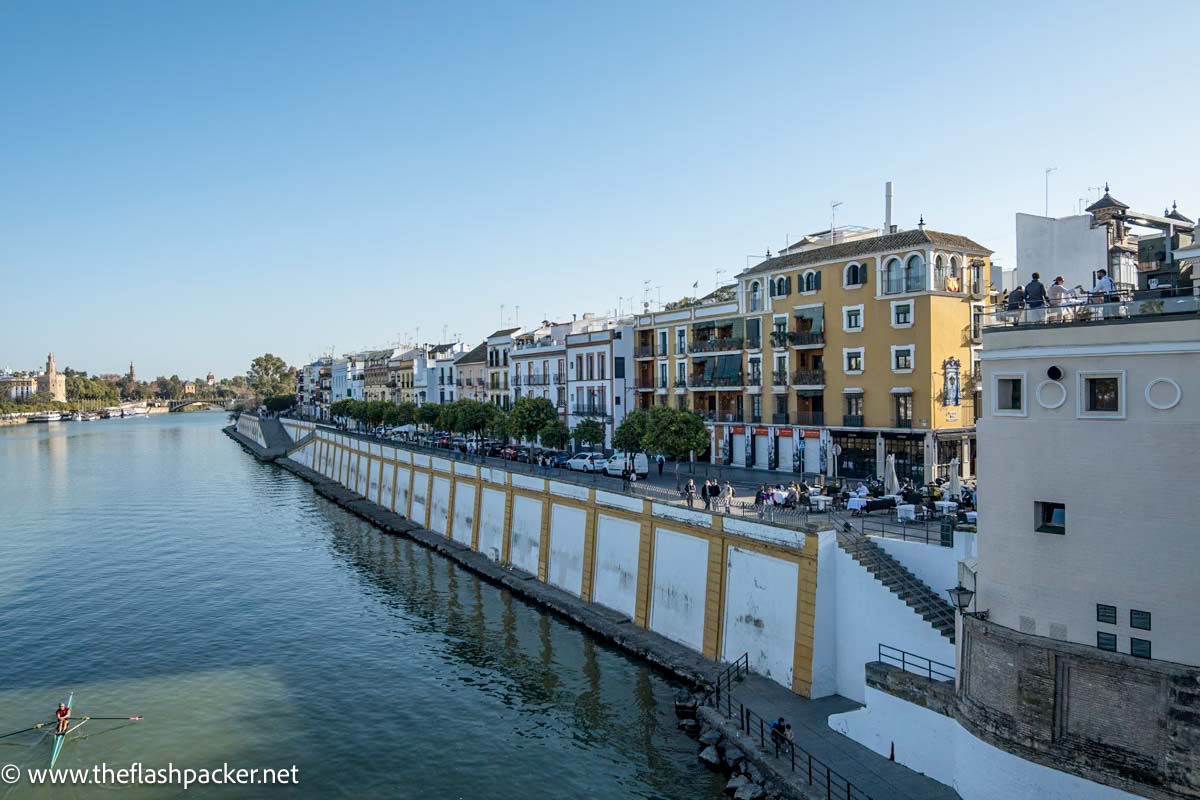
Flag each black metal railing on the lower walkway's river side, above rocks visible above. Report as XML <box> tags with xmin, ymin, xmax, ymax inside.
<box><xmin>704</xmin><ymin>654</ymin><xmax>871</xmax><ymax>800</ymax></box>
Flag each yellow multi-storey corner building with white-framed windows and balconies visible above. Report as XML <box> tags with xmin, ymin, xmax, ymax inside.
<box><xmin>635</xmin><ymin>225</ymin><xmax>991</xmax><ymax>482</ymax></box>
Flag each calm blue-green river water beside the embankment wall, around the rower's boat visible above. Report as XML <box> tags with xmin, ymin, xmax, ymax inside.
<box><xmin>0</xmin><ymin>413</ymin><xmax>721</xmax><ymax>800</ymax></box>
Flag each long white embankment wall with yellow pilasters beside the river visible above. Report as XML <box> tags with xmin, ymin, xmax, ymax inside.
<box><xmin>249</xmin><ymin>415</ymin><xmax>817</xmax><ymax>696</ymax></box>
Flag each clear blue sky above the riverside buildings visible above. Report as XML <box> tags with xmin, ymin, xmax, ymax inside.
<box><xmin>0</xmin><ymin>0</ymin><xmax>1200</xmax><ymax>378</ymax></box>
